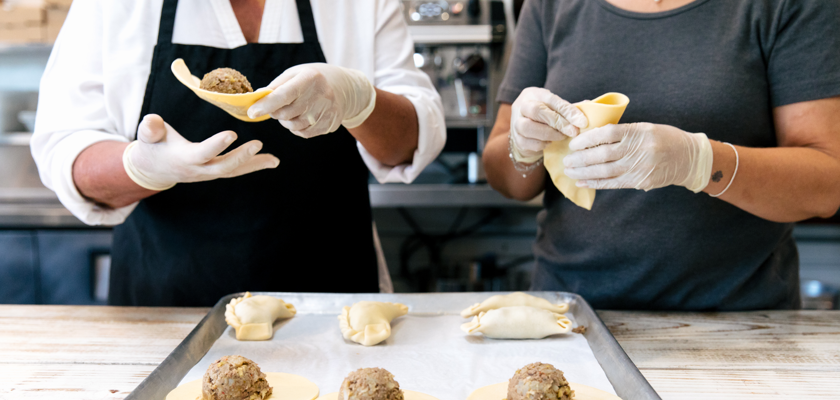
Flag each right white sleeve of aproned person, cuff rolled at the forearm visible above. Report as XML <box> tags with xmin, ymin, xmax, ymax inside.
<box><xmin>357</xmin><ymin>0</ymin><xmax>446</xmax><ymax>183</ymax></box>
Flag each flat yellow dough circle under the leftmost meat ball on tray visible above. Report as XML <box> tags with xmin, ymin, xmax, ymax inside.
<box><xmin>166</xmin><ymin>372</ymin><xmax>321</xmax><ymax>400</ymax></box>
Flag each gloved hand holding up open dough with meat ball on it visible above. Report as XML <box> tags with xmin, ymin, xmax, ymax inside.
<box><xmin>248</xmin><ymin>63</ymin><xmax>376</xmax><ymax>139</ymax></box>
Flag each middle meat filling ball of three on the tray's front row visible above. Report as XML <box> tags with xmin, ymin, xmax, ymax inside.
<box><xmin>338</xmin><ymin>368</ymin><xmax>404</xmax><ymax>400</ymax></box>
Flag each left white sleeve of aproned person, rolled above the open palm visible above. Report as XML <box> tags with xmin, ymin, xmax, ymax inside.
<box><xmin>31</xmin><ymin>0</ymin><xmax>136</xmax><ymax>225</ymax></box>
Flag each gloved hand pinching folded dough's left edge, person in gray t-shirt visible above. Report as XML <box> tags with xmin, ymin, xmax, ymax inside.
<box><xmin>510</xmin><ymin>87</ymin><xmax>589</xmax><ymax>164</ymax></box>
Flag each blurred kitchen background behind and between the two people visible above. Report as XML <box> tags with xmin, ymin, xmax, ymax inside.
<box><xmin>0</xmin><ymin>0</ymin><xmax>840</xmax><ymax>309</ymax></box>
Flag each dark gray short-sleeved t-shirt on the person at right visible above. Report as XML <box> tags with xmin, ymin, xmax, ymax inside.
<box><xmin>498</xmin><ymin>0</ymin><xmax>840</xmax><ymax>310</ymax></box>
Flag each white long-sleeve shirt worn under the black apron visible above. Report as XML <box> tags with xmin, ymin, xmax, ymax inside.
<box><xmin>31</xmin><ymin>0</ymin><xmax>446</xmax><ymax>225</ymax></box>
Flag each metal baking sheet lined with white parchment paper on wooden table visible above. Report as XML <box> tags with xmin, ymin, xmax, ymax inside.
<box><xmin>129</xmin><ymin>292</ymin><xmax>659</xmax><ymax>400</ymax></box>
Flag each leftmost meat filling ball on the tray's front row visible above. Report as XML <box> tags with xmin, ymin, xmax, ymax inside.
<box><xmin>201</xmin><ymin>356</ymin><xmax>271</xmax><ymax>400</ymax></box>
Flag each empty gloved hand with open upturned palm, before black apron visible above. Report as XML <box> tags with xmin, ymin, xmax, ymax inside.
<box><xmin>123</xmin><ymin>114</ymin><xmax>280</xmax><ymax>190</ymax></box>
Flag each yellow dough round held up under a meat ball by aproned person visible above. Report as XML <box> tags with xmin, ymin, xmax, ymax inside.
<box><xmin>170</xmin><ymin>58</ymin><xmax>271</xmax><ymax>122</ymax></box>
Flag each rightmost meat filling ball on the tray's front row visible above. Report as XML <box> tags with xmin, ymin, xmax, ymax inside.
<box><xmin>506</xmin><ymin>363</ymin><xmax>575</xmax><ymax>400</ymax></box>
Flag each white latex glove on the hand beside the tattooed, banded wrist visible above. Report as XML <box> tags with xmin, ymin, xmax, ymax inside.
<box><xmin>563</xmin><ymin>123</ymin><xmax>712</xmax><ymax>193</ymax></box>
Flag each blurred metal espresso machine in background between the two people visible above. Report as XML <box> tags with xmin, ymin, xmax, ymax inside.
<box><xmin>402</xmin><ymin>0</ymin><xmax>513</xmax><ymax>183</ymax></box>
